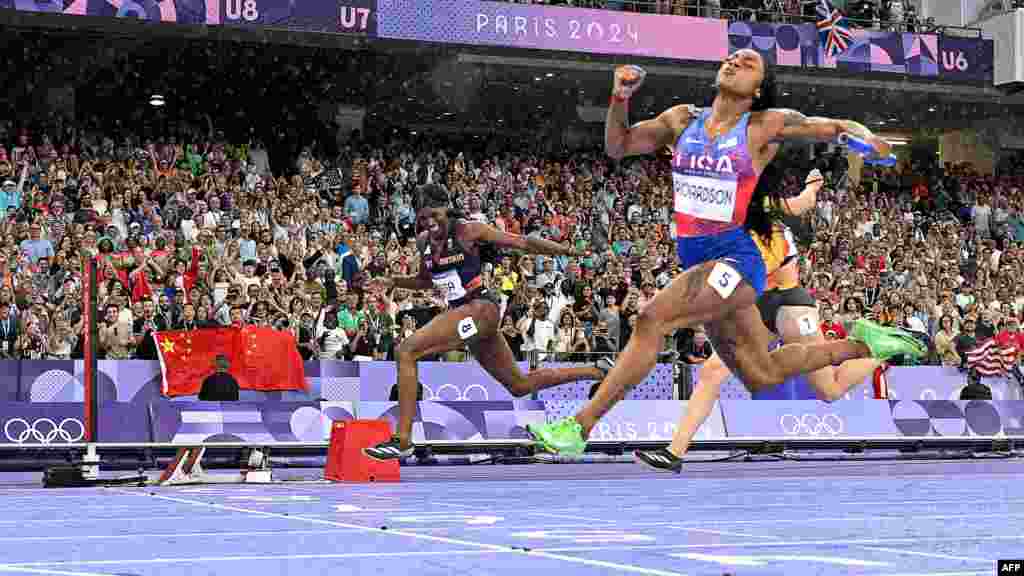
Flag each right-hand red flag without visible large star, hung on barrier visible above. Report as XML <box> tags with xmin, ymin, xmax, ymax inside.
<box><xmin>231</xmin><ymin>326</ymin><xmax>306</xmax><ymax>392</ymax></box>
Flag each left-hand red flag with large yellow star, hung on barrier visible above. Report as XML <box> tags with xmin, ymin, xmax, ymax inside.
<box><xmin>153</xmin><ymin>328</ymin><xmax>241</xmax><ymax>396</ymax></box>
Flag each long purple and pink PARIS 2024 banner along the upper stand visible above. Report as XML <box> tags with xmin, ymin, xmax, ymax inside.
<box><xmin>0</xmin><ymin>0</ymin><xmax>994</xmax><ymax>81</ymax></box>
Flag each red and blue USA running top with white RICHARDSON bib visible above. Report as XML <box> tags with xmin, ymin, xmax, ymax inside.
<box><xmin>672</xmin><ymin>109</ymin><xmax>758</xmax><ymax>238</ymax></box>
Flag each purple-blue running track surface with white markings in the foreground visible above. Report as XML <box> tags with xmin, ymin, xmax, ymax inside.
<box><xmin>0</xmin><ymin>460</ymin><xmax>1024</xmax><ymax>576</ymax></box>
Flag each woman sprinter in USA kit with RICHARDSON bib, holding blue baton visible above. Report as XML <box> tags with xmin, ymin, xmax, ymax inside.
<box><xmin>527</xmin><ymin>49</ymin><xmax>927</xmax><ymax>454</ymax></box>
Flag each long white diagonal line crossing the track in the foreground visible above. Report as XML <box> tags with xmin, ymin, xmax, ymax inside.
<box><xmin>105</xmin><ymin>492</ymin><xmax>682</xmax><ymax>576</ymax></box>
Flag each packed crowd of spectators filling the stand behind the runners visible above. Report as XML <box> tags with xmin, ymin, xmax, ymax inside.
<box><xmin>0</xmin><ymin>107</ymin><xmax>1024</xmax><ymax>365</ymax></box>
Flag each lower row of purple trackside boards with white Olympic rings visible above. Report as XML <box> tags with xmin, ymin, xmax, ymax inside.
<box><xmin>0</xmin><ymin>400</ymin><xmax>1024</xmax><ymax>446</ymax></box>
